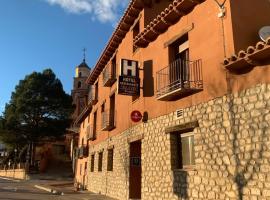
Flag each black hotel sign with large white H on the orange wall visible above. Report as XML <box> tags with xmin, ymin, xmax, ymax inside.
<box><xmin>118</xmin><ymin>59</ymin><xmax>140</xmax><ymax>96</ymax></box>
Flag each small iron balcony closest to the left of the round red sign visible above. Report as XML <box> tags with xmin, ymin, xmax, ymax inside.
<box><xmin>101</xmin><ymin>110</ymin><xmax>116</xmax><ymax>131</ymax></box>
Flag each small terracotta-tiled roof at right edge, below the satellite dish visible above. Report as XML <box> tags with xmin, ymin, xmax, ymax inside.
<box><xmin>223</xmin><ymin>37</ymin><xmax>270</xmax><ymax>71</ymax></box>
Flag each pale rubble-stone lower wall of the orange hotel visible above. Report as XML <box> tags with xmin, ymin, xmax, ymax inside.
<box><xmin>88</xmin><ymin>84</ymin><xmax>270</xmax><ymax>200</ymax></box>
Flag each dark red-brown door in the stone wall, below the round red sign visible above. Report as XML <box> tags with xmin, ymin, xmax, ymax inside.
<box><xmin>129</xmin><ymin>140</ymin><xmax>142</xmax><ymax>199</ymax></box>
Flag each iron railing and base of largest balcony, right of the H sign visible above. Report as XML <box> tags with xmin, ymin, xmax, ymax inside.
<box><xmin>157</xmin><ymin>59</ymin><xmax>203</xmax><ymax>101</ymax></box>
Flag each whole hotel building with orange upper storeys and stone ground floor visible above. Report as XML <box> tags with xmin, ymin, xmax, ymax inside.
<box><xmin>76</xmin><ymin>0</ymin><xmax>270</xmax><ymax>200</ymax></box>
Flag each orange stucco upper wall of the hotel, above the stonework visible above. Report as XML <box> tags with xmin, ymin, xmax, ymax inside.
<box><xmin>77</xmin><ymin>0</ymin><xmax>270</xmax><ymax>177</ymax></box>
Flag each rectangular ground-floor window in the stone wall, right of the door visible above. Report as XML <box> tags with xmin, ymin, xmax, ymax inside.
<box><xmin>171</xmin><ymin>132</ymin><xmax>195</xmax><ymax>169</ymax></box>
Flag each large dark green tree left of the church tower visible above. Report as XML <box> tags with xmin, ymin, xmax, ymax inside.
<box><xmin>0</xmin><ymin>69</ymin><xmax>73</xmax><ymax>162</ymax></box>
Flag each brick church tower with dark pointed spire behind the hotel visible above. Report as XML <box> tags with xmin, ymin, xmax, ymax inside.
<box><xmin>71</xmin><ymin>49</ymin><xmax>91</xmax><ymax>120</ymax></box>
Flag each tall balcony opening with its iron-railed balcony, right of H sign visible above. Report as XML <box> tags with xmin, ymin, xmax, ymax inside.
<box><xmin>156</xmin><ymin>33</ymin><xmax>203</xmax><ymax>101</ymax></box>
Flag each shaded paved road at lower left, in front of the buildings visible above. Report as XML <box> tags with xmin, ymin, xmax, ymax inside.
<box><xmin>0</xmin><ymin>178</ymin><xmax>115</xmax><ymax>200</ymax></box>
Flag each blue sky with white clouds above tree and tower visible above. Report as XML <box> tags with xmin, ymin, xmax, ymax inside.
<box><xmin>0</xmin><ymin>0</ymin><xmax>127</xmax><ymax>114</ymax></box>
